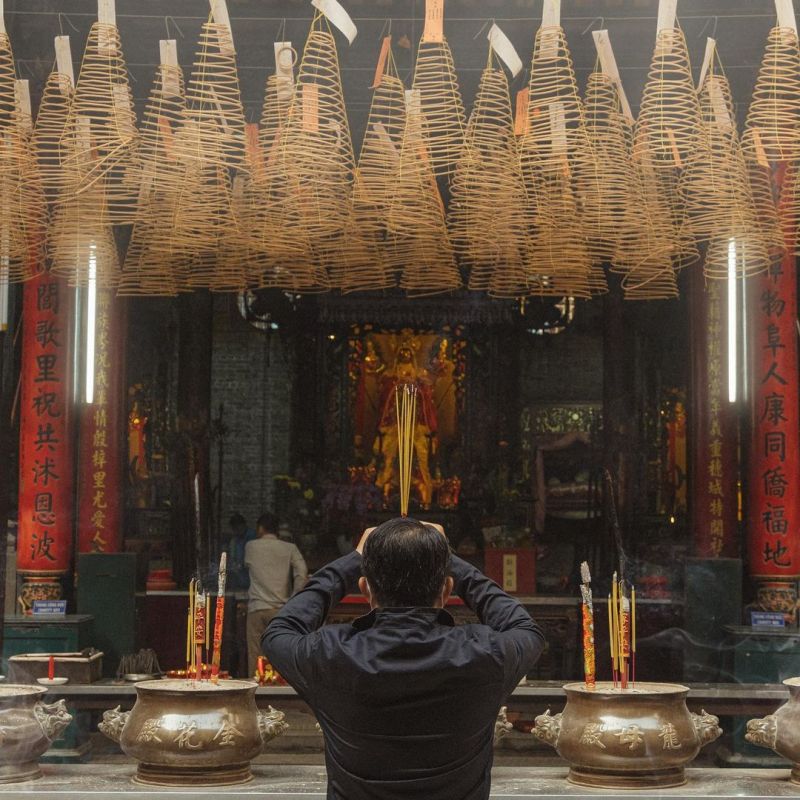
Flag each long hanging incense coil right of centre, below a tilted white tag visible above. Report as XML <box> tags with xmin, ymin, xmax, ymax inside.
<box><xmin>448</xmin><ymin>48</ymin><xmax>531</xmax><ymax>297</ymax></box>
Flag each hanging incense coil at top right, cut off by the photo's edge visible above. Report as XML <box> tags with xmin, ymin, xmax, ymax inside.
<box><xmin>742</xmin><ymin>28</ymin><xmax>800</xmax><ymax>166</ymax></box>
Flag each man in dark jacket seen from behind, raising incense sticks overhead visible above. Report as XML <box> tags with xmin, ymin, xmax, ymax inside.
<box><xmin>262</xmin><ymin>519</ymin><xmax>544</xmax><ymax>800</ymax></box>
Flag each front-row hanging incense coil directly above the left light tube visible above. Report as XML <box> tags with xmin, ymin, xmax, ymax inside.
<box><xmin>59</xmin><ymin>22</ymin><xmax>140</xmax><ymax>223</ymax></box>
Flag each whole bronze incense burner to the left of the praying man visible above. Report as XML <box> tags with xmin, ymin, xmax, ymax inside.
<box><xmin>99</xmin><ymin>679</ymin><xmax>288</xmax><ymax>786</ymax></box>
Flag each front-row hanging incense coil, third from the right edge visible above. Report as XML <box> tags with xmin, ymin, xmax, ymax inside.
<box><xmin>519</xmin><ymin>27</ymin><xmax>592</xmax><ymax>181</ymax></box>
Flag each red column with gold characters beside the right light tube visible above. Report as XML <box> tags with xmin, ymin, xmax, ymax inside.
<box><xmin>690</xmin><ymin>269</ymin><xmax>739</xmax><ymax>558</ymax></box>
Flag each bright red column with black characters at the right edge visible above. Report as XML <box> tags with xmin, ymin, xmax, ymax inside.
<box><xmin>748</xmin><ymin>166</ymin><xmax>800</xmax><ymax>578</ymax></box>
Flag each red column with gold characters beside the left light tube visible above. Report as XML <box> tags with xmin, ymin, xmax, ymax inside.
<box><xmin>78</xmin><ymin>290</ymin><xmax>125</xmax><ymax>553</ymax></box>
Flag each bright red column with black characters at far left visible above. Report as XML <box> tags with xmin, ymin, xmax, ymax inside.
<box><xmin>17</xmin><ymin>272</ymin><xmax>73</xmax><ymax>575</ymax></box>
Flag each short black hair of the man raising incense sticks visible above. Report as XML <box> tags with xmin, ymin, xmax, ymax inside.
<box><xmin>361</xmin><ymin>517</ymin><xmax>450</xmax><ymax>608</ymax></box>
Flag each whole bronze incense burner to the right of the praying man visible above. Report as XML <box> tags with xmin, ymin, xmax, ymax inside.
<box><xmin>533</xmin><ymin>681</ymin><xmax>722</xmax><ymax>789</ymax></box>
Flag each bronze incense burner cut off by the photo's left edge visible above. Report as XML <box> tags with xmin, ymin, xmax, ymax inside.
<box><xmin>0</xmin><ymin>683</ymin><xmax>72</xmax><ymax>783</ymax></box>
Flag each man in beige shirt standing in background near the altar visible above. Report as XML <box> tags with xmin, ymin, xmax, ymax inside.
<box><xmin>244</xmin><ymin>512</ymin><xmax>308</xmax><ymax>677</ymax></box>
